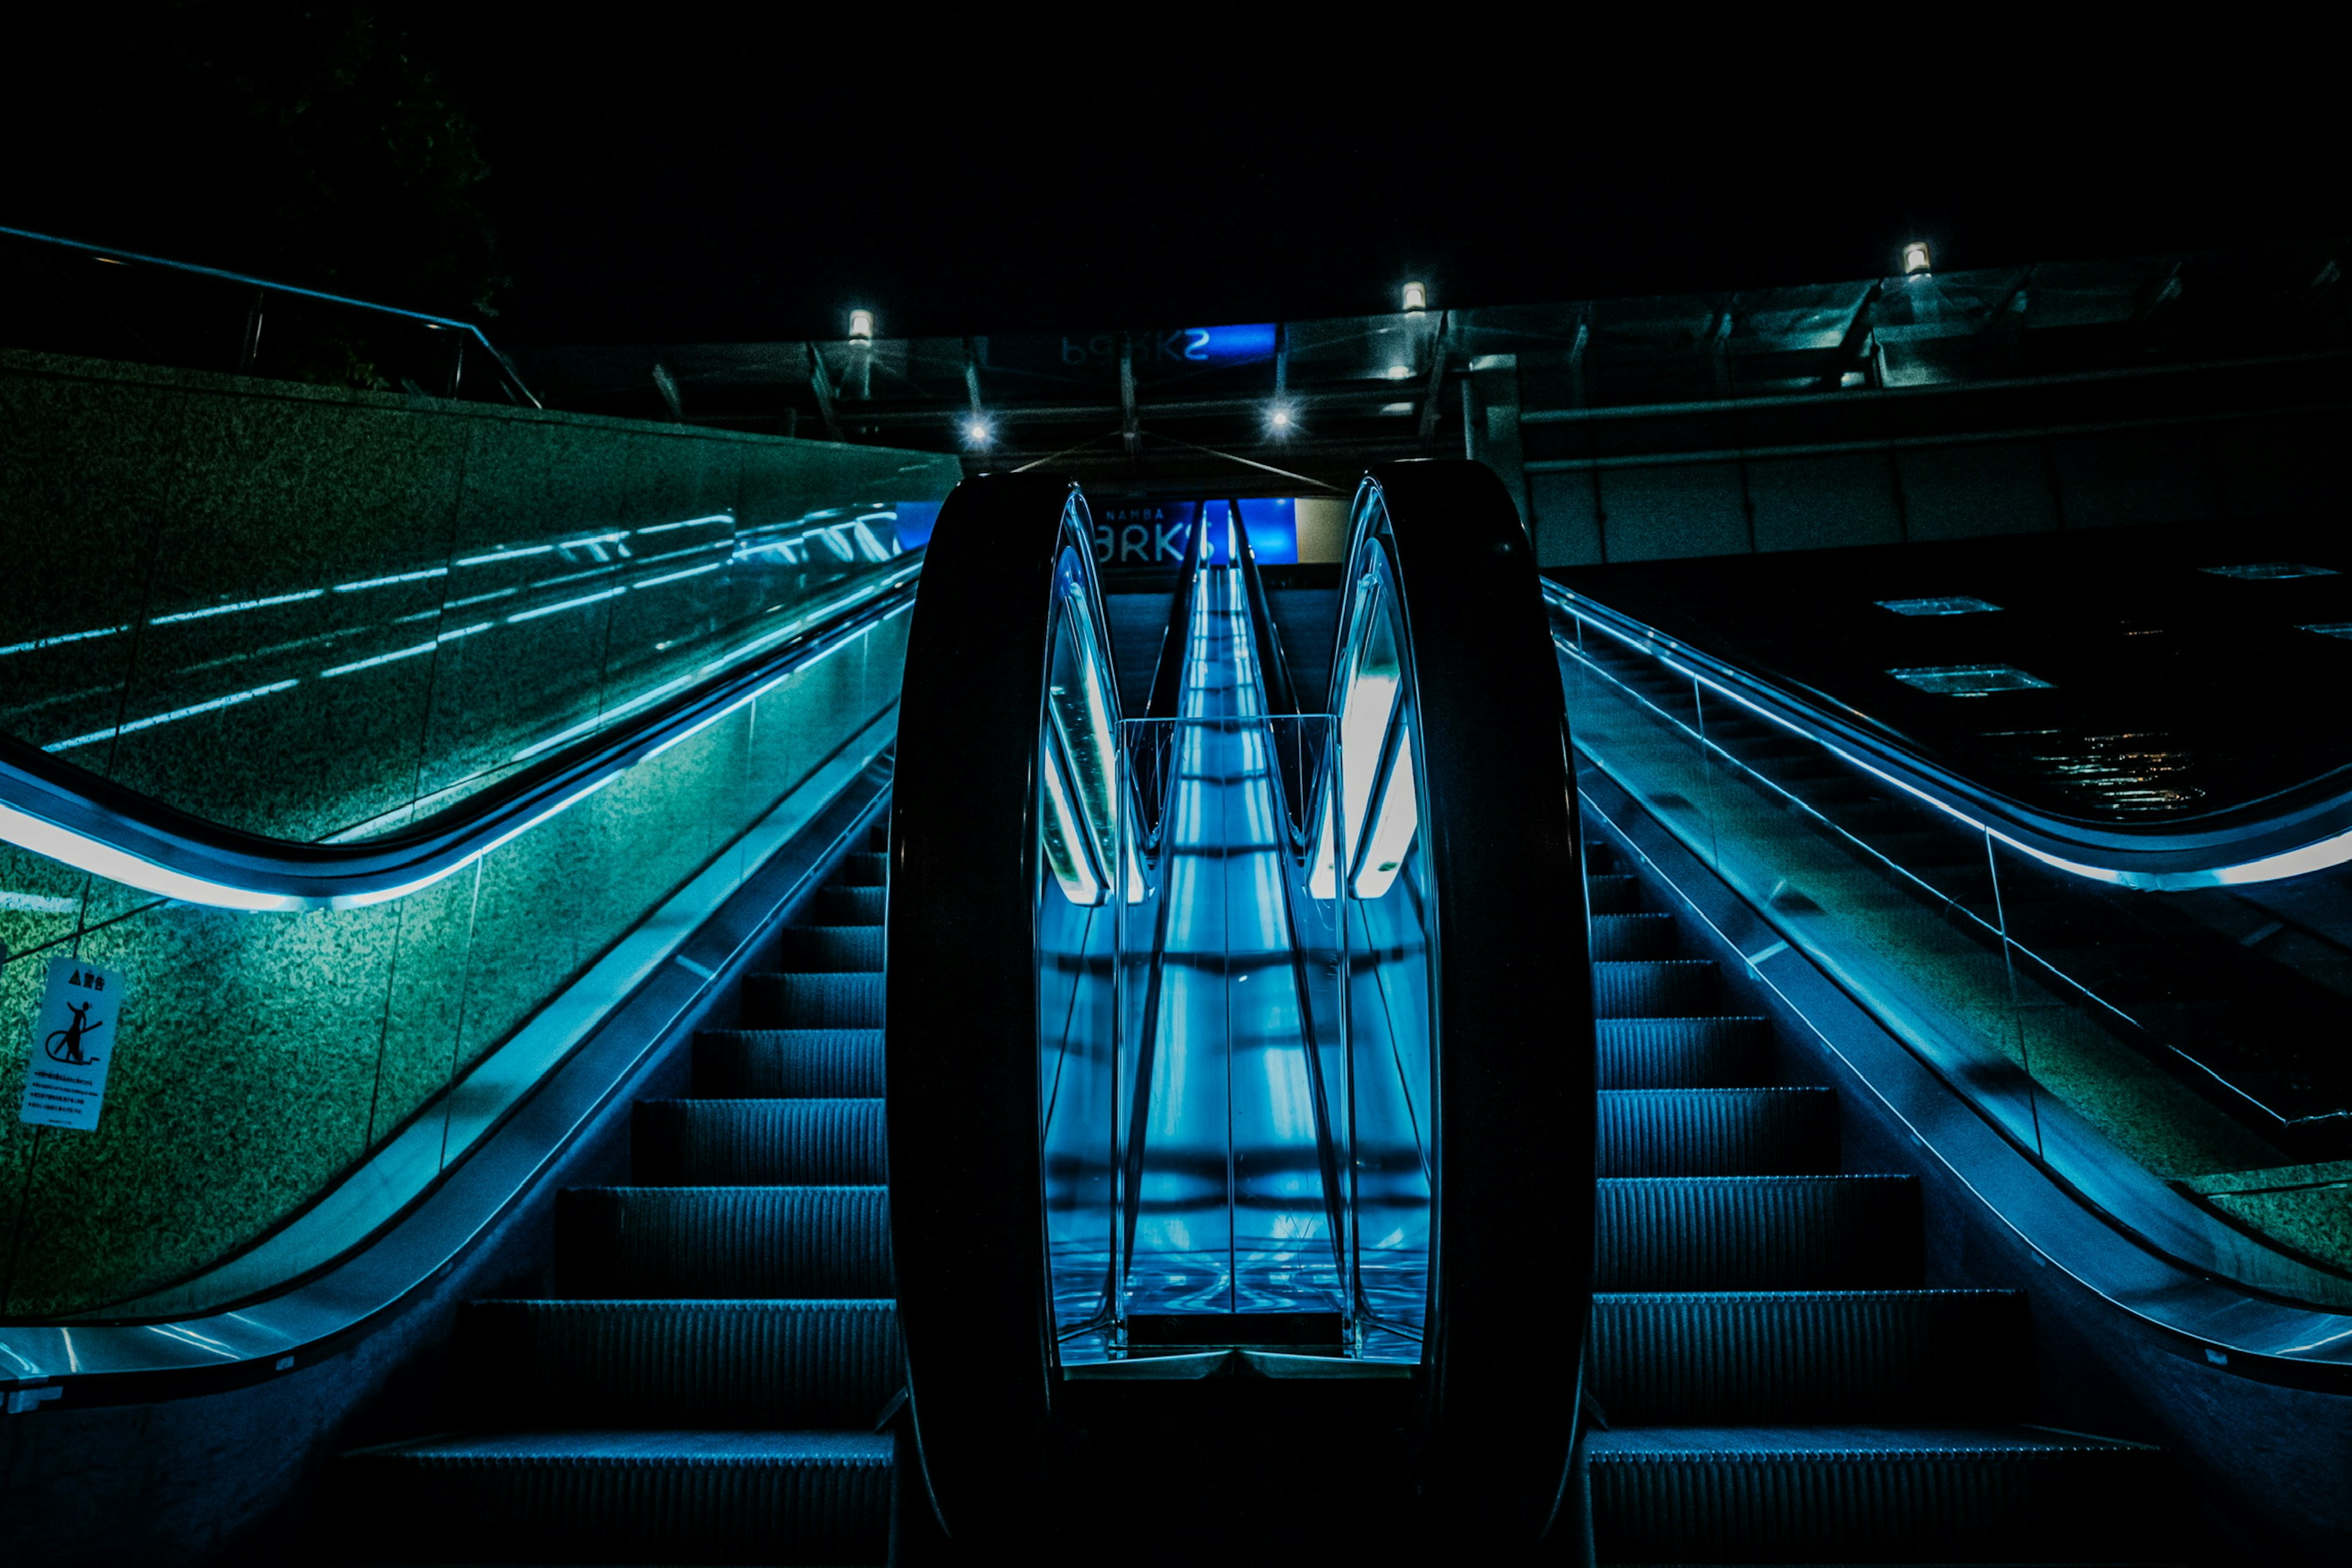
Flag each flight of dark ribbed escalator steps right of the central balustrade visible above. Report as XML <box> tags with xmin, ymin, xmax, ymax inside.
<box><xmin>1585</xmin><ymin>844</ymin><xmax>2178</xmax><ymax>1563</ymax></box>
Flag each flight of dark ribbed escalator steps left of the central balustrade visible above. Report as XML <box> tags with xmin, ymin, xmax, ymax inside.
<box><xmin>339</xmin><ymin>827</ymin><xmax>901</xmax><ymax>1563</ymax></box>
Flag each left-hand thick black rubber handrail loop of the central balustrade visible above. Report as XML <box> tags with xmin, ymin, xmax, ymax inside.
<box><xmin>884</xmin><ymin>472</ymin><xmax>1096</xmax><ymax>1551</ymax></box>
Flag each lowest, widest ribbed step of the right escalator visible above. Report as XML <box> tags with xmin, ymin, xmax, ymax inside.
<box><xmin>1585</xmin><ymin>1427</ymin><xmax>2166</xmax><ymax>1563</ymax></box>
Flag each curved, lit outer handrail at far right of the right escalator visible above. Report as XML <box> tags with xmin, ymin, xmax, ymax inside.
<box><xmin>1543</xmin><ymin>581</ymin><xmax>2352</xmax><ymax>891</ymax></box>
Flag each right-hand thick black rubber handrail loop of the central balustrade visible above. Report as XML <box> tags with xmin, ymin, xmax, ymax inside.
<box><xmin>1333</xmin><ymin>461</ymin><xmax>1597</xmax><ymax>1561</ymax></box>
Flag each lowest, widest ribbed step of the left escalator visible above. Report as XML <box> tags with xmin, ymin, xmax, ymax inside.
<box><xmin>344</xmin><ymin>1431</ymin><xmax>894</xmax><ymax>1563</ymax></box>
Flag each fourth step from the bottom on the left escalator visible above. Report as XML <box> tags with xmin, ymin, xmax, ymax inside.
<box><xmin>628</xmin><ymin>1100</ymin><xmax>889</xmax><ymax>1187</ymax></box>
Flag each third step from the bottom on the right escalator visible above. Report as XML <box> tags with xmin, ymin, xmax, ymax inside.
<box><xmin>1593</xmin><ymin>1175</ymin><xmax>1924</xmax><ymax>1291</ymax></box>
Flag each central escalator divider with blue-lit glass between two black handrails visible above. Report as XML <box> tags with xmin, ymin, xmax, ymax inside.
<box><xmin>887</xmin><ymin>466</ymin><xmax>1593</xmax><ymax>1561</ymax></box>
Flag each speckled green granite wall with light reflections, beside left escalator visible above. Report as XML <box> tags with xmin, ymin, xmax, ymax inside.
<box><xmin>0</xmin><ymin>350</ymin><xmax>960</xmax><ymax>1316</ymax></box>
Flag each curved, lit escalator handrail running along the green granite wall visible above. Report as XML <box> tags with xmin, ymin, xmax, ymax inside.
<box><xmin>0</xmin><ymin>557</ymin><xmax>922</xmax><ymax>910</ymax></box>
